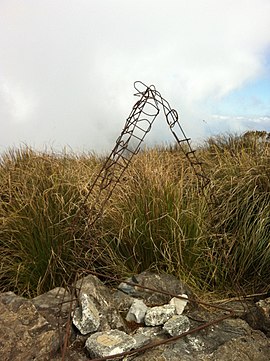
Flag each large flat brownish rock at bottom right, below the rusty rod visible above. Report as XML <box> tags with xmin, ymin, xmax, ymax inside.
<box><xmin>133</xmin><ymin>319</ymin><xmax>270</xmax><ymax>361</ymax></box>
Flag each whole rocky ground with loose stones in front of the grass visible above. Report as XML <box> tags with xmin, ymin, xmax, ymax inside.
<box><xmin>0</xmin><ymin>272</ymin><xmax>270</xmax><ymax>361</ymax></box>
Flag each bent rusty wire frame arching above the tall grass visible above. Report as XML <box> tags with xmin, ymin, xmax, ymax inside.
<box><xmin>82</xmin><ymin>81</ymin><xmax>210</xmax><ymax>226</ymax></box>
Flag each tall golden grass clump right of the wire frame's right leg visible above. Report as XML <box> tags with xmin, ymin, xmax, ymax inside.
<box><xmin>200</xmin><ymin>133</ymin><xmax>270</xmax><ymax>292</ymax></box>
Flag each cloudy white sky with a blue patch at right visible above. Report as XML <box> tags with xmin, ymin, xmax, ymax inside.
<box><xmin>0</xmin><ymin>0</ymin><xmax>270</xmax><ymax>152</ymax></box>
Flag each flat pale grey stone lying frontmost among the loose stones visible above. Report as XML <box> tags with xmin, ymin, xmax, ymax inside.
<box><xmin>85</xmin><ymin>330</ymin><xmax>136</xmax><ymax>357</ymax></box>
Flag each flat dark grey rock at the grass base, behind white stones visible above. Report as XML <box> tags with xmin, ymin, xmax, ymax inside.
<box><xmin>118</xmin><ymin>271</ymin><xmax>192</xmax><ymax>306</ymax></box>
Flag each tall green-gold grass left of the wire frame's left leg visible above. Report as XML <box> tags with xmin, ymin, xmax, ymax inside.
<box><xmin>0</xmin><ymin>149</ymin><xmax>97</xmax><ymax>296</ymax></box>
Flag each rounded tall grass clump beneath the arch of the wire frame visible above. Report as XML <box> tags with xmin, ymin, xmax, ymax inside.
<box><xmin>93</xmin><ymin>150</ymin><xmax>209</xmax><ymax>286</ymax></box>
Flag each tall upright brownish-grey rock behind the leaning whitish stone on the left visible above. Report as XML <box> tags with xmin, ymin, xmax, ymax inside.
<box><xmin>76</xmin><ymin>275</ymin><xmax>126</xmax><ymax>331</ymax></box>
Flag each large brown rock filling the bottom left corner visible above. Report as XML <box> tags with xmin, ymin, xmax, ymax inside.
<box><xmin>0</xmin><ymin>292</ymin><xmax>60</xmax><ymax>361</ymax></box>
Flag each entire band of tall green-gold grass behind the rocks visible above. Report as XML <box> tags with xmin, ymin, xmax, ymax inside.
<box><xmin>0</xmin><ymin>132</ymin><xmax>270</xmax><ymax>296</ymax></box>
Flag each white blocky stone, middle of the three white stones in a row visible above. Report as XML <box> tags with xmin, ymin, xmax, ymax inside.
<box><xmin>144</xmin><ymin>305</ymin><xmax>175</xmax><ymax>326</ymax></box>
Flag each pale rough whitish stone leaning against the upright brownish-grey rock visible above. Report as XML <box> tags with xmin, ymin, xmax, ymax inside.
<box><xmin>72</xmin><ymin>293</ymin><xmax>100</xmax><ymax>335</ymax></box>
